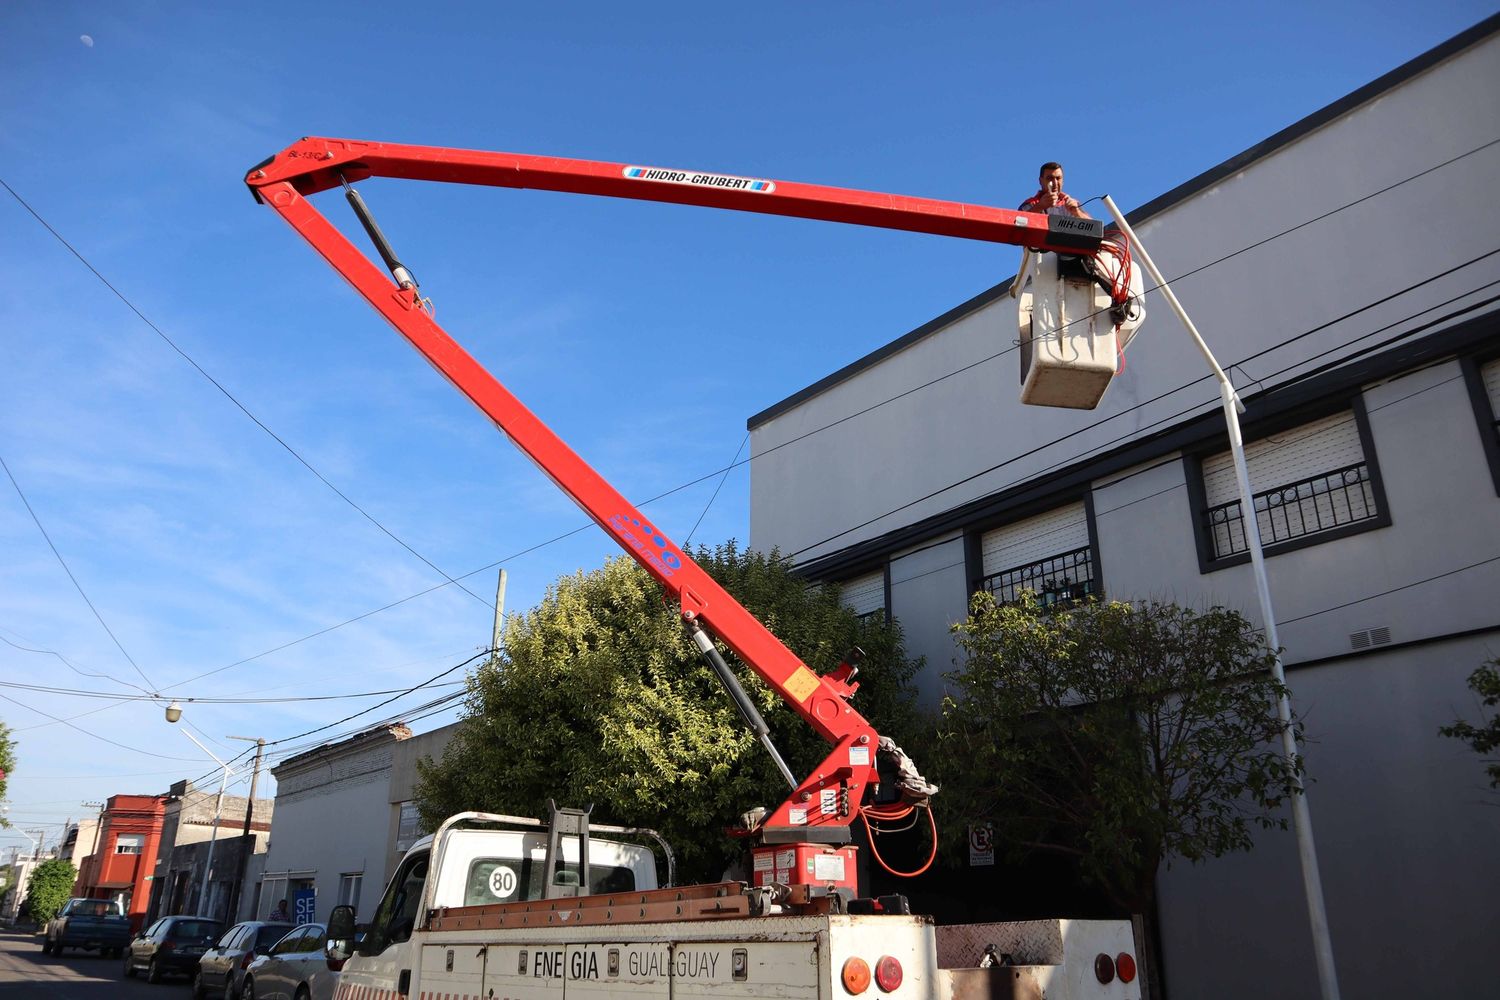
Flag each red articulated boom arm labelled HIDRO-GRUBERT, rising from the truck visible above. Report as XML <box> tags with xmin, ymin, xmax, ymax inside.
<box><xmin>246</xmin><ymin>138</ymin><xmax>1103</xmax><ymax>863</ymax></box>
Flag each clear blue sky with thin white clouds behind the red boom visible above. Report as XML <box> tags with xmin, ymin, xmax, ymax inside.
<box><xmin>0</xmin><ymin>0</ymin><xmax>1493</xmax><ymax>847</ymax></box>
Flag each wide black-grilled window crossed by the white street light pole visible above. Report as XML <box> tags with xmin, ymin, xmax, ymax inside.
<box><xmin>1200</xmin><ymin>409</ymin><xmax>1389</xmax><ymax>561</ymax></box>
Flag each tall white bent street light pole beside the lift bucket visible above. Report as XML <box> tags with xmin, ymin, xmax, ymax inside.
<box><xmin>1104</xmin><ymin>195</ymin><xmax>1340</xmax><ymax>1000</ymax></box>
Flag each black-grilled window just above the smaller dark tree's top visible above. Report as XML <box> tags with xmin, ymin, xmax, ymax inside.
<box><xmin>975</xmin><ymin>501</ymin><xmax>1100</xmax><ymax>606</ymax></box>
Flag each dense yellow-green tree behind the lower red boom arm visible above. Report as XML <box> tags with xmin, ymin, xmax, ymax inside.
<box><xmin>417</xmin><ymin>543</ymin><xmax>917</xmax><ymax>882</ymax></box>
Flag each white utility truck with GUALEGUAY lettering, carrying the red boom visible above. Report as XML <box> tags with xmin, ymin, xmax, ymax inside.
<box><xmin>327</xmin><ymin>813</ymin><xmax>1142</xmax><ymax>1000</ymax></box>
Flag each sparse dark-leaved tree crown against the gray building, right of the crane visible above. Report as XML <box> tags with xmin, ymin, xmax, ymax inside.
<box><xmin>936</xmin><ymin>594</ymin><xmax>1301</xmax><ymax>913</ymax></box>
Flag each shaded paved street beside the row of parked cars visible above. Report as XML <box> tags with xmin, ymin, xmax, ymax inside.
<box><xmin>0</xmin><ymin>930</ymin><xmax>189</xmax><ymax>1000</ymax></box>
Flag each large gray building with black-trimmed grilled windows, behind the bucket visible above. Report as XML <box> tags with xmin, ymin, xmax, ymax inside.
<box><xmin>749</xmin><ymin>16</ymin><xmax>1500</xmax><ymax>999</ymax></box>
